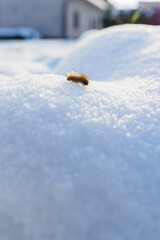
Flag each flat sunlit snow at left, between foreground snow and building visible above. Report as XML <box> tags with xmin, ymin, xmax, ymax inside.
<box><xmin>0</xmin><ymin>40</ymin><xmax>75</xmax><ymax>76</ymax></box>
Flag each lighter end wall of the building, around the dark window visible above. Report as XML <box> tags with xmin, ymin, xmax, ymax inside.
<box><xmin>66</xmin><ymin>0</ymin><xmax>103</xmax><ymax>38</ymax></box>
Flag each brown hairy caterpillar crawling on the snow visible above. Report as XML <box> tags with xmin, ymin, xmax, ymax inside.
<box><xmin>67</xmin><ymin>73</ymin><xmax>89</xmax><ymax>85</ymax></box>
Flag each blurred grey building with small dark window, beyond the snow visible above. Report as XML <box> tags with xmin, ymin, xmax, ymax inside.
<box><xmin>0</xmin><ymin>0</ymin><xmax>107</xmax><ymax>38</ymax></box>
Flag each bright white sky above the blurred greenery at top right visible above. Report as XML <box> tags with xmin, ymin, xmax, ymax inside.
<box><xmin>110</xmin><ymin>0</ymin><xmax>160</xmax><ymax>8</ymax></box>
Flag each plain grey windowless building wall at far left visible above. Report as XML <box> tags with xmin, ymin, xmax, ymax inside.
<box><xmin>0</xmin><ymin>0</ymin><xmax>64</xmax><ymax>37</ymax></box>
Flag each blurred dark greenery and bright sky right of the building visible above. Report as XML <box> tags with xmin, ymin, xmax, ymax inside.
<box><xmin>103</xmin><ymin>0</ymin><xmax>160</xmax><ymax>27</ymax></box>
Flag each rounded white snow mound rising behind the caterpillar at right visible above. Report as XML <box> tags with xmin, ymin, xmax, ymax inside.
<box><xmin>54</xmin><ymin>25</ymin><xmax>160</xmax><ymax>81</ymax></box>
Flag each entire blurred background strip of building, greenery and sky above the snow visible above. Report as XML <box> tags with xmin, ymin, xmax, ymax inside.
<box><xmin>0</xmin><ymin>0</ymin><xmax>160</xmax><ymax>39</ymax></box>
